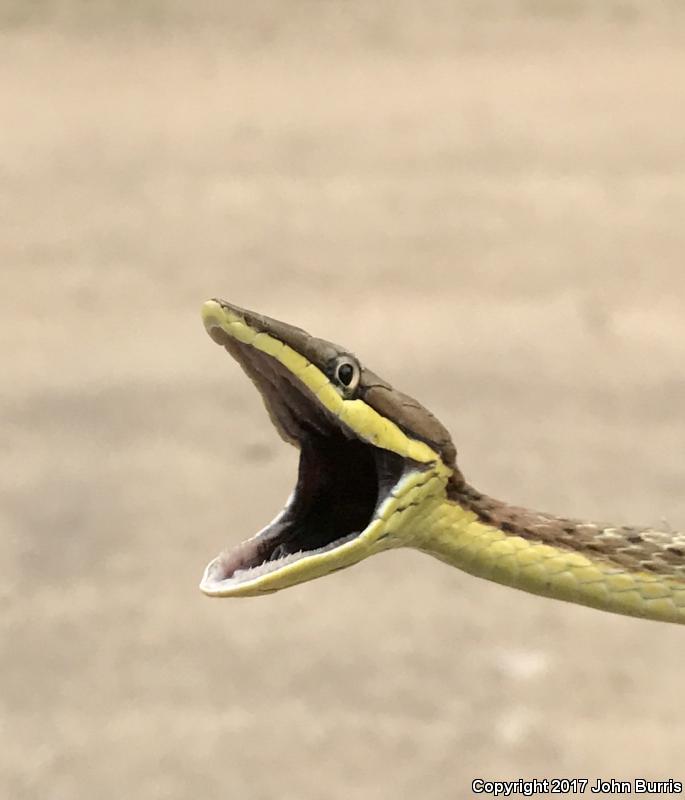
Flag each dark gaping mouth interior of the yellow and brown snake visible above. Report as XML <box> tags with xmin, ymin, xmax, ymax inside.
<box><xmin>201</xmin><ymin>318</ymin><xmax>412</xmax><ymax>595</ymax></box>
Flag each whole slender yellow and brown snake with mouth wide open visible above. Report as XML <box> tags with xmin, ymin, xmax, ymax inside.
<box><xmin>200</xmin><ymin>299</ymin><xmax>685</xmax><ymax>624</ymax></box>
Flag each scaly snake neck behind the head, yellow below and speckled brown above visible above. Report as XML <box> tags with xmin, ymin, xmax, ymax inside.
<box><xmin>412</xmin><ymin>473</ymin><xmax>685</xmax><ymax>623</ymax></box>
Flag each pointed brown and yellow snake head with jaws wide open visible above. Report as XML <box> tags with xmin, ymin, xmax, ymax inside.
<box><xmin>200</xmin><ymin>300</ymin><xmax>456</xmax><ymax>597</ymax></box>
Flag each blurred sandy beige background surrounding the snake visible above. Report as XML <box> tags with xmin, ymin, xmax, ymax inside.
<box><xmin>0</xmin><ymin>0</ymin><xmax>685</xmax><ymax>800</ymax></box>
